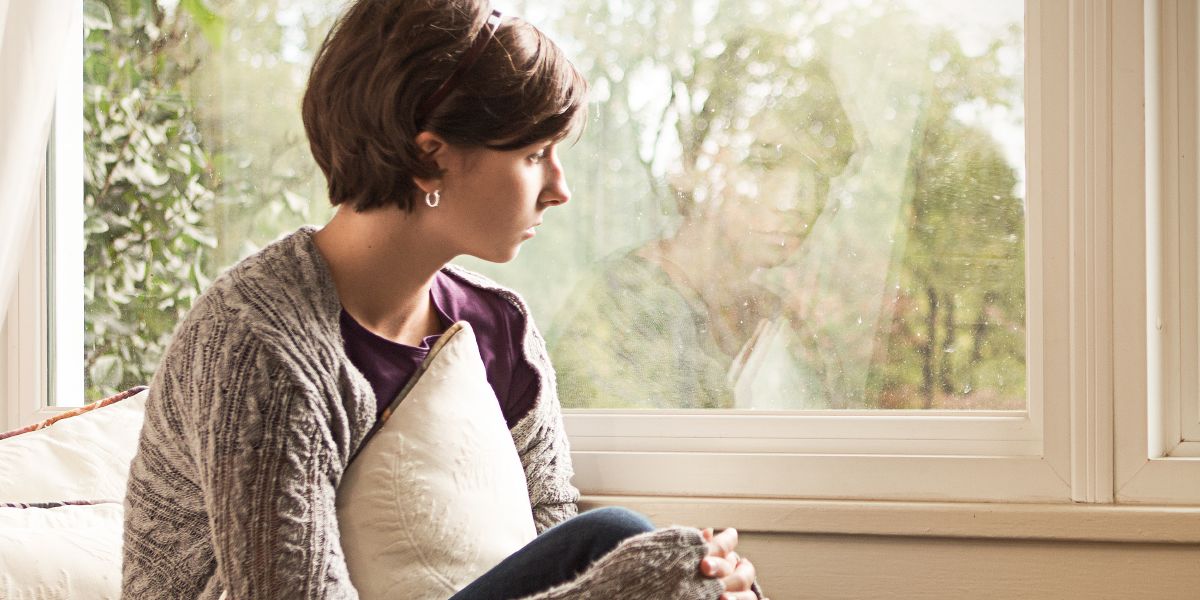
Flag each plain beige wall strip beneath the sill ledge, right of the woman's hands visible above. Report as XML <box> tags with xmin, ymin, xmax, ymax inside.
<box><xmin>740</xmin><ymin>535</ymin><xmax>1200</xmax><ymax>600</ymax></box>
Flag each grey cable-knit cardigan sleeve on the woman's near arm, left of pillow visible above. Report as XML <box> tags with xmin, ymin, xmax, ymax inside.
<box><xmin>198</xmin><ymin>336</ymin><xmax>358</xmax><ymax>600</ymax></box>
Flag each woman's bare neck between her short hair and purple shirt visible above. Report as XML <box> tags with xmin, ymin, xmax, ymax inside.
<box><xmin>313</xmin><ymin>205</ymin><xmax>454</xmax><ymax>346</ymax></box>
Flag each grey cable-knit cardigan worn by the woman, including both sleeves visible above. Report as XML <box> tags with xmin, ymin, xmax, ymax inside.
<box><xmin>122</xmin><ymin>228</ymin><xmax>721</xmax><ymax>600</ymax></box>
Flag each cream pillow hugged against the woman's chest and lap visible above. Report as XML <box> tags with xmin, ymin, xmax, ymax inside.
<box><xmin>337</xmin><ymin>322</ymin><xmax>536</xmax><ymax>600</ymax></box>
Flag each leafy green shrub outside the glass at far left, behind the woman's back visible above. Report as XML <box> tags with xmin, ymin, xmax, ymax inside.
<box><xmin>84</xmin><ymin>0</ymin><xmax>215</xmax><ymax>398</ymax></box>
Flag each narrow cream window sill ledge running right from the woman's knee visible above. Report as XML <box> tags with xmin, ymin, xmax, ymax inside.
<box><xmin>580</xmin><ymin>496</ymin><xmax>1200</xmax><ymax>544</ymax></box>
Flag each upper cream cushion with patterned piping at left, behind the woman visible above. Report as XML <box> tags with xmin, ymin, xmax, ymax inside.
<box><xmin>0</xmin><ymin>390</ymin><xmax>150</xmax><ymax>503</ymax></box>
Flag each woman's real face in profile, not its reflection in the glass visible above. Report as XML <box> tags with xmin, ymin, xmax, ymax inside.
<box><xmin>427</xmin><ymin>142</ymin><xmax>571</xmax><ymax>263</ymax></box>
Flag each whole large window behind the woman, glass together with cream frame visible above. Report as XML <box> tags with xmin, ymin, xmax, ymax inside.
<box><xmin>11</xmin><ymin>0</ymin><xmax>1200</xmax><ymax>502</ymax></box>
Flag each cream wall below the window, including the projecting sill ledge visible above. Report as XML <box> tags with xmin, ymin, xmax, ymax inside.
<box><xmin>582</xmin><ymin>497</ymin><xmax>1200</xmax><ymax>600</ymax></box>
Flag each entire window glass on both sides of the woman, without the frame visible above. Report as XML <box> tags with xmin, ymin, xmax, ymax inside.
<box><xmin>85</xmin><ymin>0</ymin><xmax>1026</xmax><ymax>409</ymax></box>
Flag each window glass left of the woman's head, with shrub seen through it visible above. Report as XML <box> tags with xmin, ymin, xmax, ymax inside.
<box><xmin>84</xmin><ymin>0</ymin><xmax>341</xmax><ymax>398</ymax></box>
